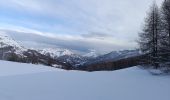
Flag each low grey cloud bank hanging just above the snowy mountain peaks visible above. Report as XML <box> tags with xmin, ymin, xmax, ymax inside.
<box><xmin>1</xmin><ymin>30</ymin><xmax>135</xmax><ymax>54</ymax></box>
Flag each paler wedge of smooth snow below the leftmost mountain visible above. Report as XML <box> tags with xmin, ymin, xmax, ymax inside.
<box><xmin>0</xmin><ymin>60</ymin><xmax>62</xmax><ymax>76</ymax></box>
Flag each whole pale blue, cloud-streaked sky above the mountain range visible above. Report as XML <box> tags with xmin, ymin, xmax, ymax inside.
<box><xmin>0</xmin><ymin>0</ymin><xmax>163</xmax><ymax>53</ymax></box>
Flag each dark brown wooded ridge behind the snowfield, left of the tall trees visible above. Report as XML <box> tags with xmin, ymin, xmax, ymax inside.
<box><xmin>71</xmin><ymin>55</ymin><xmax>147</xmax><ymax>72</ymax></box>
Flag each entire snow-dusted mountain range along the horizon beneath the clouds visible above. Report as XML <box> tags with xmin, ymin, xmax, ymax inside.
<box><xmin>0</xmin><ymin>32</ymin><xmax>143</xmax><ymax>67</ymax></box>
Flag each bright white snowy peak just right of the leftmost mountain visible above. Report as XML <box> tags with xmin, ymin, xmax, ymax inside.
<box><xmin>37</xmin><ymin>48</ymin><xmax>74</xmax><ymax>58</ymax></box>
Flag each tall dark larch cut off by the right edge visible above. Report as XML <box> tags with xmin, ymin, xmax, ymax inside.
<box><xmin>161</xmin><ymin>0</ymin><xmax>170</xmax><ymax>67</ymax></box>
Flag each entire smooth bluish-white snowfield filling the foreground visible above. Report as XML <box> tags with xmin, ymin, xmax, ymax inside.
<box><xmin>0</xmin><ymin>61</ymin><xmax>170</xmax><ymax>100</ymax></box>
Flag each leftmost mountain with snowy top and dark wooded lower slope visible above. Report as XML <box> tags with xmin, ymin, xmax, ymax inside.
<box><xmin>0</xmin><ymin>32</ymin><xmax>61</xmax><ymax>65</ymax></box>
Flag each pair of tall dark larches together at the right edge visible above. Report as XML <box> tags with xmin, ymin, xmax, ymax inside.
<box><xmin>139</xmin><ymin>0</ymin><xmax>170</xmax><ymax>69</ymax></box>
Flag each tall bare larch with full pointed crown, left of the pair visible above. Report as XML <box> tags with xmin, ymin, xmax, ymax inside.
<box><xmin>139</xmin><ymin>2</ymin><xmax>161</xmax><ymax>68</ymax></box>
